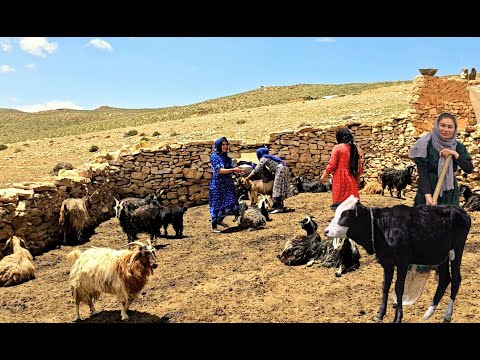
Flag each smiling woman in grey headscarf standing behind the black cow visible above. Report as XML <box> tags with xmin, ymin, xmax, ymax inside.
<box><xmin>408</xmin><ymin>112</ymin><xmax>473</xmax><ymax>206</ymax></box>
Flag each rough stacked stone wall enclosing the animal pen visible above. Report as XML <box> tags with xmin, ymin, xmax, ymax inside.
<box><xmin>0</xmin><ymin>76</ymin><xmax>480</xmax><ymax>255</ymax></box>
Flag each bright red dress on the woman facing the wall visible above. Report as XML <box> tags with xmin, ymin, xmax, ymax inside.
<box><xmin>325</xmin><ymin>144</ymin><xmax>362</xmax><ymax>203</ymax></box>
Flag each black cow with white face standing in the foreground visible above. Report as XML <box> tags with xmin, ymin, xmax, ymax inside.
<box><xmin>325</xmin><ymin>195</ymin><xmax>471</xmax><ymax>322</ymax></box>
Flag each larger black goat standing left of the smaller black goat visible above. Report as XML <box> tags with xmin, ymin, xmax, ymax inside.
<box><xmin>118</xmin><ymin>200</ymin><xmax>168</xmax><ymax>242</ymax></box>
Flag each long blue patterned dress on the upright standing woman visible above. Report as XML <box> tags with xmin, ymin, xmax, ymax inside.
<box><xmin>209</xmin><ymin>152</ymin><xmax>239</xmax><ymax>224</ymax></box>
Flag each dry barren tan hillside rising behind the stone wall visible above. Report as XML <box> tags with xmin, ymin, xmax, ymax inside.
<box><xmin>0</xmin><ymin>81</ymin><xmax>412</xmax><ymax>187</ymax></box>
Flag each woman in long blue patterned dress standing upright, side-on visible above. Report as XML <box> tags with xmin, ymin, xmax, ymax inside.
<box><xmin>209</xmin><ymin>137</ymin><xmax>243</xmax><ymax>233</ymax></box>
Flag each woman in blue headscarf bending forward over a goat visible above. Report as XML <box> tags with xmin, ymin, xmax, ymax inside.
<box><xmin>246</xmin><ymin>147</ymin><xmax>292</xmax><ymax>214</ymax></box>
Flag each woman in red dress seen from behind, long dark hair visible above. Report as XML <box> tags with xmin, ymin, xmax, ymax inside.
<box><xmin>320</xmin><ymin>127</ymin><xmax>363</xmax><ymax>204</ymax></box>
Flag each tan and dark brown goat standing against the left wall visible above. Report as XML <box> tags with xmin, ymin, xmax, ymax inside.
<box><xmin>58</xmin><ymin>189</ymin><xmax>98</xmax><ymax>244</ymax></box>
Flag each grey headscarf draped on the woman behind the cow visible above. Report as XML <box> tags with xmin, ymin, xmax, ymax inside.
<box><xmin>408</xmin><ymin>112</ymin><xmax>457</xmax><ymax>197</ymax></box>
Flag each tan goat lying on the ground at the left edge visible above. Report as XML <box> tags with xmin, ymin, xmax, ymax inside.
<box><xmin>0</xmin><ymin>236</ymin><xmax>35</xmax><ymax>286</ymax></box>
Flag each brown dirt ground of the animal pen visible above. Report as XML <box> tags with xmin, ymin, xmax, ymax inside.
<box><xmin>0</xmin><ymin>193</ymin><xmax>480</xmax><ymax>323</ymax></box>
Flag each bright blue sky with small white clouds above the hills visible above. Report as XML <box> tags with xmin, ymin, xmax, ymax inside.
<box><xmin>0</xmin><ymin>37</ymin><xmax>480</xmax><ymax>111</ymax></box>
